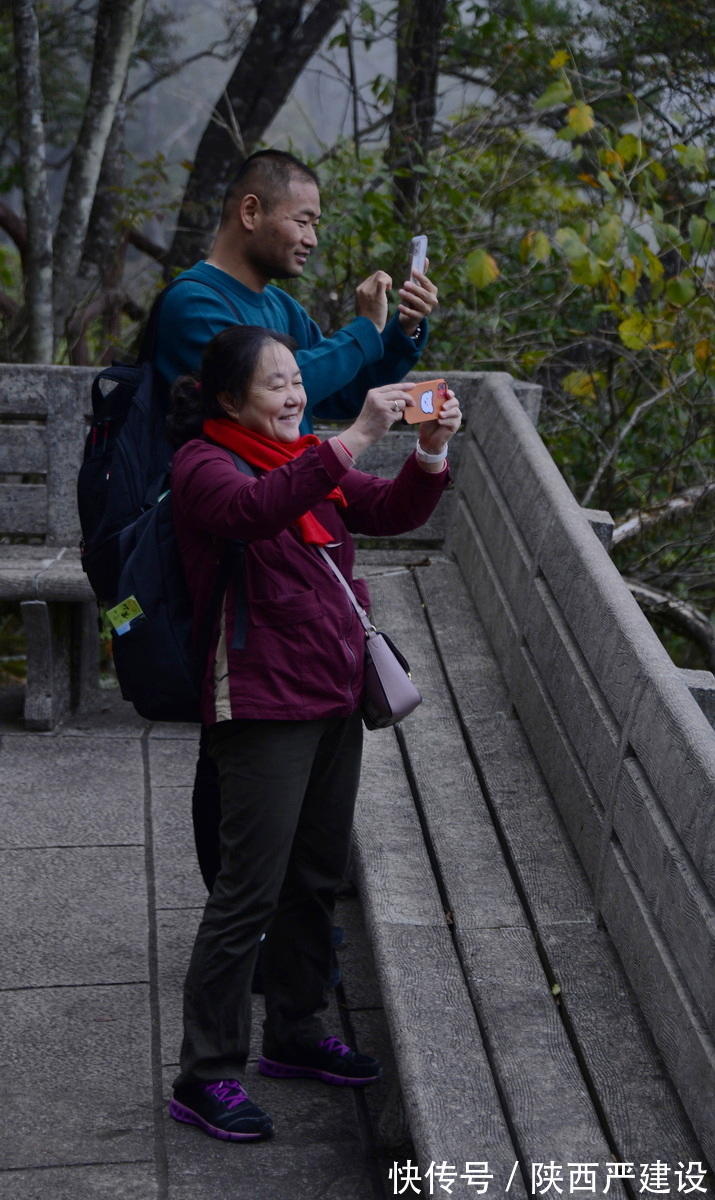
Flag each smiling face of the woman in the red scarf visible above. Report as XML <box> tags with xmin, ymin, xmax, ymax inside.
<box><xmin>224</xmin><ymin>342</ymin><xmax>306</xmax><ymax>442</ymax></box>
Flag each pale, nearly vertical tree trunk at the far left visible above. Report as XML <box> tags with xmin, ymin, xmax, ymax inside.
<box><xmin>12</xmin><ymin>0</ymin><xmax>53</xmax><ymax>362</ymax></box>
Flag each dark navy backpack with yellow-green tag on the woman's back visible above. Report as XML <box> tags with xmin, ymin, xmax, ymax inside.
<box><xmin>107</xmin><ymin>455</ymin><xmax>256</xmax><ymax>721</ymax></box>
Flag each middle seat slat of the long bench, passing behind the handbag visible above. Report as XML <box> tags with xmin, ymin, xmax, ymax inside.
<box><xmin>364</xmin><ymin>572</ymin><xmax>609</xmax><ymax>1162</ymax></box>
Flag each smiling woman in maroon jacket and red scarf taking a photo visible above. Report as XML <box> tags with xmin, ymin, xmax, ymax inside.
<box><xmin>169</xmin><ymin>325</ymin><xmax>461</xmax><ymax>1140</ymax></box>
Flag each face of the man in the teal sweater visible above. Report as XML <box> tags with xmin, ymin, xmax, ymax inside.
<box><xmin>248</xmin><ymin>178</ymin><xmax>320</xmax><ymax>283</ymax></box>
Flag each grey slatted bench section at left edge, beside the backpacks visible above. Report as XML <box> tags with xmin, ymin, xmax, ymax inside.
<box><xmin>0</xmin><ymin>365</ymin><xmax>98</xmax><ymax>730</ymax></box>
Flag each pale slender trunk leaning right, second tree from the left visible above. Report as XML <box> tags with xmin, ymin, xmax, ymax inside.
<box><xmin>55</xmin><ymin>0</ymin><xmax>145</xmax><ymax>336</ymax></box>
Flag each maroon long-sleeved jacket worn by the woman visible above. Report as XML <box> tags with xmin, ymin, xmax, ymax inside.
<box><xmin>172</xmin><ymin>439</ymin><xmax>449</xmax><ymax>725</ymax></box>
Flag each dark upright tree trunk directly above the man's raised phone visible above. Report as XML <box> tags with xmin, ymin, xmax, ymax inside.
<box><xmin>387</xmin><ymin>0</ymin><xmax>446</xmax><ymax>227</ymax></box>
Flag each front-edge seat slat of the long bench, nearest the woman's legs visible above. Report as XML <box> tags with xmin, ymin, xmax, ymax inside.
<box><xmin>354</xmin><ymin>730</ymin><xmax>525</xmax><ymax>1185</ymax></box>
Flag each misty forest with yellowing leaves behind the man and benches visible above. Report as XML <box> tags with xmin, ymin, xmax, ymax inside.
<box><xmin>0</xmin><ymin>0</ymin><xmax>715</xmax><ymax>670</ymax></box>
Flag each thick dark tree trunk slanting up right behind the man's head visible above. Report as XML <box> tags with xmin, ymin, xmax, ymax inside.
<box><xmin>167</xmin><ymin>0</ymin><xmax>347</xmax><ymax>271</ymax></box>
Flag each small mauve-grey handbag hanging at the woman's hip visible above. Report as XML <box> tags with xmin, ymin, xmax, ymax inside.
<box><xmin>318</xmin><ymin>546</ymin><xmax>422</xmax><ymax>730</ymax></box>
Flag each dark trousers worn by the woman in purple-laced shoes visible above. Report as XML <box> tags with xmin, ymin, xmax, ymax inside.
<box><xmin>178</xmin><ymin>713</ymin><xmax>362</xmax><ymax>1082</ymax></box>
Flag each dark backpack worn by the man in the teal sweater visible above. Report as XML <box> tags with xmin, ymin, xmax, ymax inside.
<box><xmin>77</xmin><ymin>276</ymin><xmax>240</xmax><ymax>604</ymax></box>
